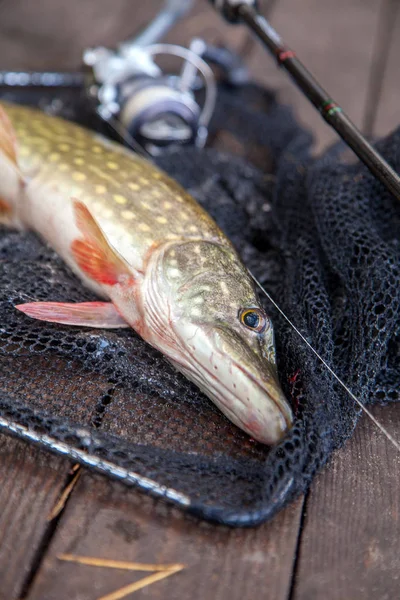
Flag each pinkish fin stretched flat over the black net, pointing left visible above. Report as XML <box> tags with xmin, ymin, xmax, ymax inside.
<box><xmin>15</xmin><ymin>302</ymin><xmax>129</xmax><ymax>329</ymax></box>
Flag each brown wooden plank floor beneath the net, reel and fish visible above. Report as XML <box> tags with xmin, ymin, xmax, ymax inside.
<box><xmin>0</xmin><ymin>0</ymin><xmax>400</xmax><ymax>600</ymax></box>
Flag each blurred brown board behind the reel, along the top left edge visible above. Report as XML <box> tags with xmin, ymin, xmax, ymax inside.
<box><xmin>0</xmin><ymin>0</ymin><xmax>255</xmax><ymax>70</ymax></box>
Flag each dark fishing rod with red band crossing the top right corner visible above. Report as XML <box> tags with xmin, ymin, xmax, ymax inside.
<box><xmin>210</xmin><ymin>0</ymin><xmax>400</xmax><ymax>201</ymax></box>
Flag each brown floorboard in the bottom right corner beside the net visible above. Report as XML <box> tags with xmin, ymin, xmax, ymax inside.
<box><xmin>293</xmin><ymin>405</ymin><xmax>400</xmax><ymax>600</ymax></box>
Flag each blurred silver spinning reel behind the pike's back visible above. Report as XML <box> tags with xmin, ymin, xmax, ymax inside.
<box><xmin>83</xmin><ymin>0</ymin><xmax>247</xmax><ymax>156</ymax></box>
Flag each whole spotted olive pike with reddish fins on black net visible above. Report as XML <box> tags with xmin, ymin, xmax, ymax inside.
<box><xmin>0</xmin><ymin>102</ymin><xmax>292</xmax><ymax>444</ymax></box>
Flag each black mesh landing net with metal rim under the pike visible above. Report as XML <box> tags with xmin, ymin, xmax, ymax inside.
<box><xmin>0</xmin><ymin>85</ymin><xmax>400</xmax><ymax>526</ymax></box>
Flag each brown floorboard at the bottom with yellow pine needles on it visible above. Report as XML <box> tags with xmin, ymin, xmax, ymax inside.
<box><xmin>27</xmin><ymin>475</ymin><xmax>302</xmax><ymax>600</ymax></box>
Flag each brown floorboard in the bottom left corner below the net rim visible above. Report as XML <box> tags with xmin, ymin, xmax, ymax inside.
<box><xmin>0</xmin><ymin>434</ymin><xmax>70</xmax><ymax>600</ymax></box>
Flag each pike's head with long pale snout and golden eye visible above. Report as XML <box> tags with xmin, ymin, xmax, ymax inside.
<box><xmin>155</xmin><ymin>241</ymin><xmax>292</xmax><ymax>444</ymax></box>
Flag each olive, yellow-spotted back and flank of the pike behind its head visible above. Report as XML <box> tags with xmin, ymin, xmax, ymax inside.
<box><xmin>7</xmin><ymin>105</ymin><xmax>228</xmax><ymax>266</ymax></box>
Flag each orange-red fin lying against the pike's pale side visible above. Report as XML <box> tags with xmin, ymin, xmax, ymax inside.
<box><xmin>71</xmin><ymin>199</ymin><xmax>134</xmax><ymax>285</ymax></box>
